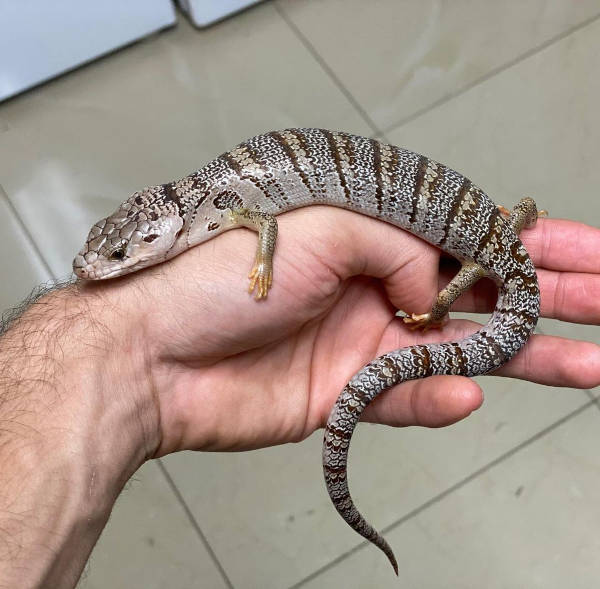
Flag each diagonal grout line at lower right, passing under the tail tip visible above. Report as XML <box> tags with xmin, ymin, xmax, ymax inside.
<box><xmin>288</xmin><ymin>398</ymin><xmax>600</xmax><ymax>589</ymax></box>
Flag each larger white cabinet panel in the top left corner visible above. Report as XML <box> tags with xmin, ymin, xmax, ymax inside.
<box><xmin>0</xmin><ymin>0</ymin><xmax>175</xmax><ymax>100</ymax></box>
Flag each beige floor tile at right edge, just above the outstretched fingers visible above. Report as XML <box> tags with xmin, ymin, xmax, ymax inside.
<box><xmin>388</xmin><ymin>16</ymin><xmax>600</xmax><ymax>342</ymax></box>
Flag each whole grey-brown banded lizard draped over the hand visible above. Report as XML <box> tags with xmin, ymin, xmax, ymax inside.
<box><xmin>73</xmin><ymin>129</ymin><xmax>545</xmax><ymax>575</ymax></box>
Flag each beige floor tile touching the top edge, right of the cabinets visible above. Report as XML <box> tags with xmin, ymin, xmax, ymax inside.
<box><xmin>279</xmin><ymin>0</ymin><xmax>599</xmax><ymax>130</ymax></box>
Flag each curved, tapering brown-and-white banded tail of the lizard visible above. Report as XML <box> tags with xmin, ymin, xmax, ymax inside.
<box><xmin>323</xmin><ymin>258</ymin><xmax>539</xmax><ymax>574</ymax></box>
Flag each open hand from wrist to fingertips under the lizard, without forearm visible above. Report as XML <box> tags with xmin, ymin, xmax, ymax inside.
<box><xmin>84</xmin><ymin>207</ymin><xmax>600</xmax><ymax>456</ymax></box>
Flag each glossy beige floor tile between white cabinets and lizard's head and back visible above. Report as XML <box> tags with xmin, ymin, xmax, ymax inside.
<box><xmin>0</xmin><ymin>4</ymin><xmax>369</xmax><ymax>275</ymax></box>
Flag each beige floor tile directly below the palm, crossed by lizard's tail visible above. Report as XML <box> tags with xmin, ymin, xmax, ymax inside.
<box><xmin>168</xmin><ymin>378</ymin><xmax>588</xmax><ymax>589</ymax></box>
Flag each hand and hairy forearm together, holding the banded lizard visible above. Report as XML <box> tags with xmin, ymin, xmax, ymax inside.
<box><xmin>0</xmin><ymin>207</ymin><xmax>600</xmax><ymax>588</ymax></box>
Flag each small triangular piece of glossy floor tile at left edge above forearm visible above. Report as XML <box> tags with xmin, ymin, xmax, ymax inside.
<box><xmin>0</xmin><ymin>185</ymin><xmax>51</xmax><ymax>315</ymax></box>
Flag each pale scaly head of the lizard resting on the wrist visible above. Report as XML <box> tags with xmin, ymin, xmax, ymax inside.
<box><xmin>73</xmin><ymin>188</ymin><xmax>183</xmax><ymax>280</ymax></box>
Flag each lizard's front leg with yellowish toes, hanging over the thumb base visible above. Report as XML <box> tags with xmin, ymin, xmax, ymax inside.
<box><xmin>229</xmin><ymin>208</ymin><xmax>277</xmax><ymax>300</ymax></box>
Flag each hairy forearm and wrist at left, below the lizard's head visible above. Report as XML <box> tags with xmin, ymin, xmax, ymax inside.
<box><xmin>0</xmin><ymin>287</ymin><xmax>158</xmax><ymax>588</ymax></box>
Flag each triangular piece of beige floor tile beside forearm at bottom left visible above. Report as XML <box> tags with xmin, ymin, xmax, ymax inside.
<box><xmin>78</xmin><ymin>462</ymin><xmax>227</xmax><ymax>589</ymax></box>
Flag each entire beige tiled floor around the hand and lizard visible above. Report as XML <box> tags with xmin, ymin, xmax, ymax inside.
<box><xmin>0</xmin><ymin>0</ymin><xmax>600</xmax><ymax>589</ymax></box>
